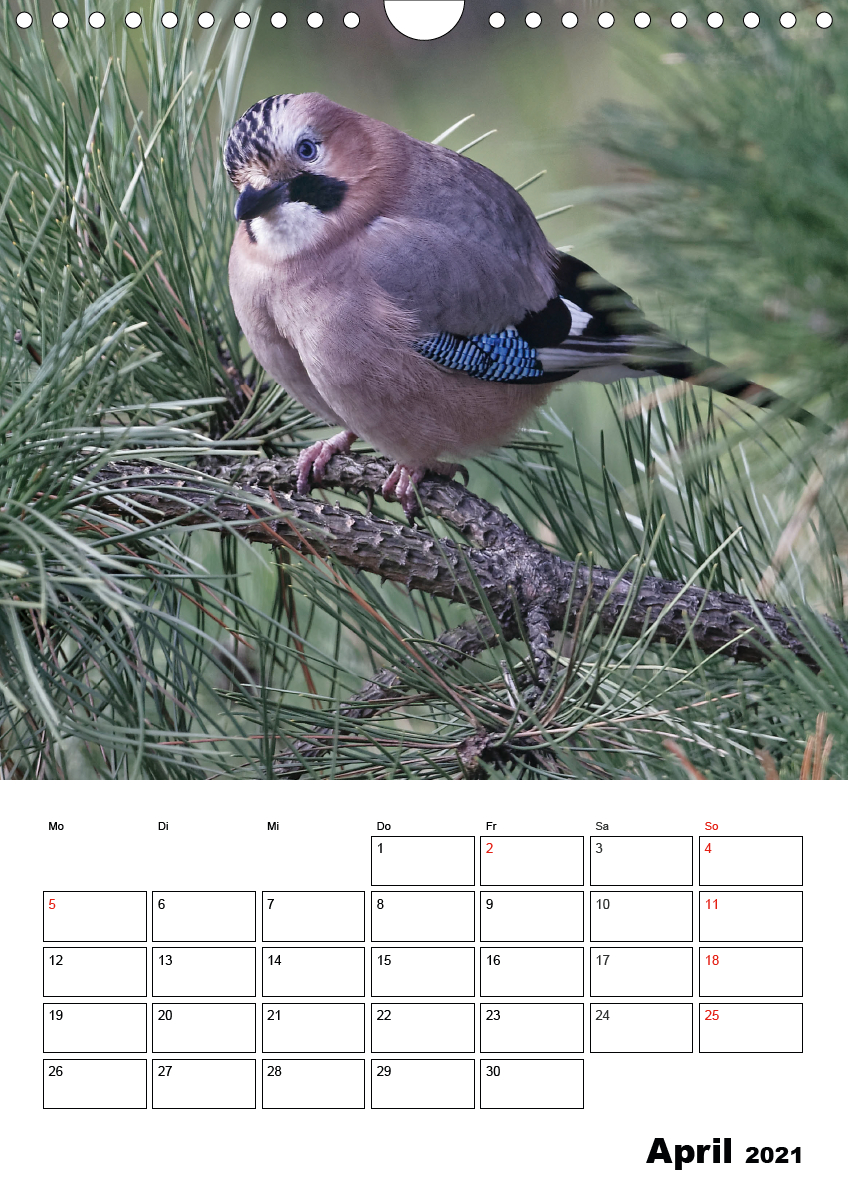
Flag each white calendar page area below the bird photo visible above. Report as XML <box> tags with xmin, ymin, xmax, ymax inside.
<box><xmin>2</xmin><ymin>782</ymin><xmax>846</xmax><ymax>1200</ymax></box>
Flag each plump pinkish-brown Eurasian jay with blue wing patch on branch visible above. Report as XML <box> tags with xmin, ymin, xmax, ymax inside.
<box><xmin>224</xmin><ymin>92</ymin><xmax>774</xmax><ymax>512</ymax></box>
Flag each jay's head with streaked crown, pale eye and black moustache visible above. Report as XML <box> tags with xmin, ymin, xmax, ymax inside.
<box><xmin>224</xmin><ymin>92</ymin><xmax>389</xmax><ymax>257</ymax></box>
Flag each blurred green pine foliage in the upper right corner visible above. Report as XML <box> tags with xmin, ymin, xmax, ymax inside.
<box><xmin>585</xmin><ymin>0</ymin><xmax>848</xmax><ymax>432</ymax></box>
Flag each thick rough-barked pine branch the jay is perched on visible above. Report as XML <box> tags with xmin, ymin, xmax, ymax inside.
<box><xmin>89</xmin><ymin>455</ymin><xmax>848</xmax><ymax>667</ymax></box>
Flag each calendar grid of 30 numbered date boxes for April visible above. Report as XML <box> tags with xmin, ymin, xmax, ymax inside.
<box><xmin>42</xmin><ymin>828</ymin><xmax>804</xmax><ymax>1110</ymax></box>
